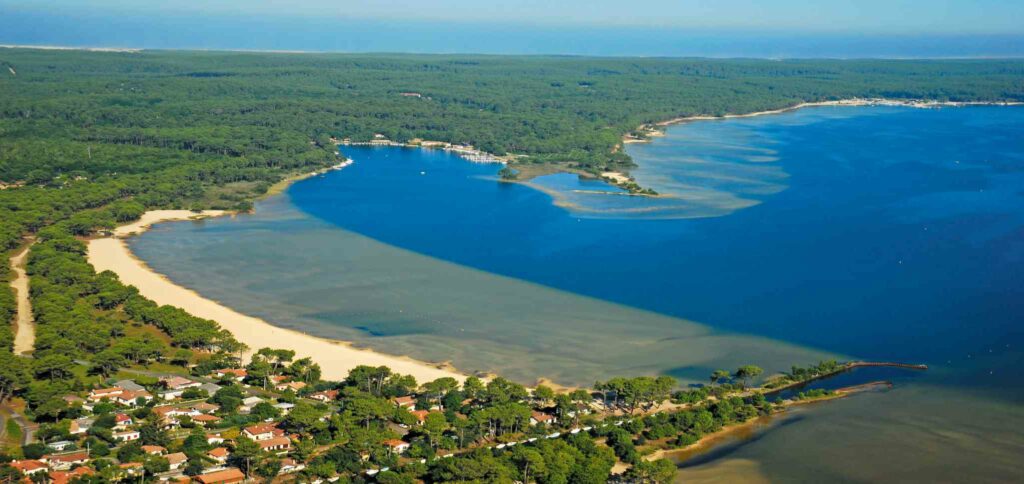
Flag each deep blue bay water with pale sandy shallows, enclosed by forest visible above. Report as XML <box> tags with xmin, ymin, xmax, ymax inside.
<box><xmin>131</xmin><ymin>106</ymin><xmax>1024</xmax><ymax>481</ymax></box>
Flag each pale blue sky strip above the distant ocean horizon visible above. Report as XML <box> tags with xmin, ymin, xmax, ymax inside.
<box><xmin>6</xmin><ymin>0</ymin><xmax>1024</xmax><ymax>35</ymax></box>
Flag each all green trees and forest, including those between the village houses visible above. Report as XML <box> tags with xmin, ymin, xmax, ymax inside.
<box><xmin>0</xmin><ymin>49</ymin><xmax>1024</xmax><ymax>482</ymax></box>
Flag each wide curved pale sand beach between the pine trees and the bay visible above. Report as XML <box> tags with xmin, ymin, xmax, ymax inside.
<box><xmin>88</xmin><ymin>210</ymin><xmax>465</xmax><ymax>383</ymax></box>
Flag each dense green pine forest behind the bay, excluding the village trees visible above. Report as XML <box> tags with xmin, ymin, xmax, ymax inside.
<box><xmin>0</xmin><ymin>48</ymin><xmax>1024</xmax><ymax>478</ymax></box>
